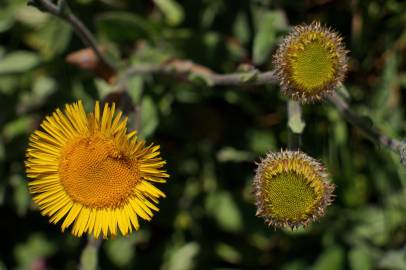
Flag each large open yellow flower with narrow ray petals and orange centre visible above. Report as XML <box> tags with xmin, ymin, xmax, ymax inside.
<box><xmin>26</xmin><ymin>101</ymin><xmax>169</xmax><ymax>238</ymax></box>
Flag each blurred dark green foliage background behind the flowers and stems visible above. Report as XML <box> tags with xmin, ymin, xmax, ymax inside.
<box><xmin>0</xmin><ymin>0</ymin><xmax>406</xmax><ymax>270</ymax></box>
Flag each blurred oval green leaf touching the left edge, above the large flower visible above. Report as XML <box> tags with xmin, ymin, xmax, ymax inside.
<box><xmin>0</xmin><ymin>51</ymin><xmax>40</xmax><ymax>75</ymax></box>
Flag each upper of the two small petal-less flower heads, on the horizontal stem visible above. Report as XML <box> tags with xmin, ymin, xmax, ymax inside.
<box><xmin>273</xmin><ymin>22</ymin><xmax>347</xmax><ymax>103</ymax></box>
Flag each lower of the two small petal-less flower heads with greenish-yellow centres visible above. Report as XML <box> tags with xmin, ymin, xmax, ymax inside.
<box><xmin>254</xmin><ymin>151</ymin><xmax>334</xmax><ymax>228</ymax></box>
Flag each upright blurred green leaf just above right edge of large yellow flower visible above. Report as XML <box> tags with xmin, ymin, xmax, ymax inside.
<box><xmin>140</xmin><ymin>96</ymin><xmax>159</xmax><ymax>138</ymax></box>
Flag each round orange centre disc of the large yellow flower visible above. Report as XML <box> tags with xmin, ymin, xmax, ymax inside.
<box><xmin>59</xmin><ymin>135</ymin><xmax>140</xmax><ymax>208</ymax></box>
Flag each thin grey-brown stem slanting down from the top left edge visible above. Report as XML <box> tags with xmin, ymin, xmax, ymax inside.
<box><xmin>28</xmin><ymin>0</ymin><xmax>116</xmax><ymax>70</ymax></box>
